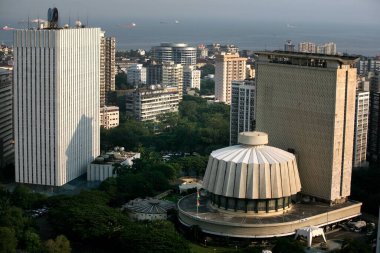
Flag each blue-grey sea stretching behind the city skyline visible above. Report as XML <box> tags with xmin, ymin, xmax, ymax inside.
<box><xmin>0</xmin><ymin>19</ymin><xmax>380</xmax><ymax>56</ymax></box>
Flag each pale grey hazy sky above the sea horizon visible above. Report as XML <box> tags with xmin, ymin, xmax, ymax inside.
<box><xmin>0</xmin><ymin>0</ymin><xmax>380</xmax><ymax>25</ymax></box>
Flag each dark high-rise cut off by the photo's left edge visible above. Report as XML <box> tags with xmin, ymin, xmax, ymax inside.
<box><xmin>0</xmin><ymin>68</ymin><xmax>14</xmax><ymax>169</ymax></box>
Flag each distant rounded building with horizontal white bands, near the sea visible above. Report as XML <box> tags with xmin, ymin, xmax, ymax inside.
<box><xmin>152</xmin><ymin>43</ymin><xmax>197</xmax><ymax>65</ymax></box>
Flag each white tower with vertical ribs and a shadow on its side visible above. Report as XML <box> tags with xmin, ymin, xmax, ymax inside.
<box><xmin>13</xmin><ymin>28</ymin><xmax>101</xmax><ymax>186</ymax></box>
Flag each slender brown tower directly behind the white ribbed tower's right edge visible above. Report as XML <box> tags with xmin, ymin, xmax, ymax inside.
<box><xmin>100</xmin><ymin>36</ymin><xmax>116</xmax><ymax>107</ymax></box>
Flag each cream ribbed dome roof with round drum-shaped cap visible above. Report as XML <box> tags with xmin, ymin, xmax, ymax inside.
<box><xmin>203</xmin><ymin>132</ymin><xmax>301</xmax><ymax>199</ymax></box>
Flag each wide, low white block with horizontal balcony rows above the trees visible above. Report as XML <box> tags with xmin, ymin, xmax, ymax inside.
<box><xmin>126</xmin><ymin>85</ymin><xmax>179</xmax><ymax>121</ymax></box>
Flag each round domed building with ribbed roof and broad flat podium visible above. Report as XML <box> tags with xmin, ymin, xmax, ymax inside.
<box><xmin>178</xmin><ymin>132</ymin><xmax>361</xmax><ymax>238</ymax></box>
